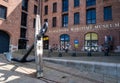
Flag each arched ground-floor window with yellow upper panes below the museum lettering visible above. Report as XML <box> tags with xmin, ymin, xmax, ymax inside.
<box><xmin>85</xmin><ymin>32</ymin><xmax>98</xmax><ymax>51</ymax></box>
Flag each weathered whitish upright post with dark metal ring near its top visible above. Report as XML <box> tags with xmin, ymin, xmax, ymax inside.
<box><xmin>34</xmin><ymin>15</ymin><xmax>48</xmax><ymax>78</ymax></box>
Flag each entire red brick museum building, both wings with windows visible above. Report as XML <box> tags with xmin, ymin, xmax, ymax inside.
<box><xmin>0</xmin><ymin>0</ymin><xmax>120</xmax><ymax>53</ymax></box>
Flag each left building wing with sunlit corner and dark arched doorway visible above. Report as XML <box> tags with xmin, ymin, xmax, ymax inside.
<box><xmin>0</xmin><ymin>0</ymin><xmax>38</xmax><ymax>53</ymax></box>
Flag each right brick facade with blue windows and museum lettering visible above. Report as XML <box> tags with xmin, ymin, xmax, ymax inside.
<box><xmin>41</xmin><ymin>0</ymin><xmax>120</xmax><ymax>52</ymax></box>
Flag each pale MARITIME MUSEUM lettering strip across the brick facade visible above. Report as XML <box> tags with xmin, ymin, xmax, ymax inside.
<box><xmin>49</xmin><ymin>22</ymin><xmax>120</xmax><ymax>33</ymax></box>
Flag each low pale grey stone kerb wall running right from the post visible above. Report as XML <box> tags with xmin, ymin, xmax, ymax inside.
<box><xmin>44</xmin><ymin>58</ymin><xmax>120</xmax><ymax>79</ymax></box>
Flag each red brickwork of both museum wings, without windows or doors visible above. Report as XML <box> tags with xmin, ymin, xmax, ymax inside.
<box><xmin>0</xmin><ymin>0</ymin><xmax>120</xmax><ymax>50</ymax></box>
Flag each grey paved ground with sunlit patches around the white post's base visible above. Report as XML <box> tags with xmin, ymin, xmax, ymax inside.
<box><xmin>0</xmin><ymin>55</ymin><xmax>105</xmax><ymax>83</ymax></box>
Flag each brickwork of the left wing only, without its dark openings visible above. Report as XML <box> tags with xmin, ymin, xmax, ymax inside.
<box><xmin>0</xmin><ymin>0</ymin><xmax>38</xmax><ymax>50</ymax></box>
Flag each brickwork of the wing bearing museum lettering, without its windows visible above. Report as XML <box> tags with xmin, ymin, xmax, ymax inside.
<box><xmin>42</xmin><ymin>0</ymin><xmax>120</xmax><ymax>50</ymax></box>
